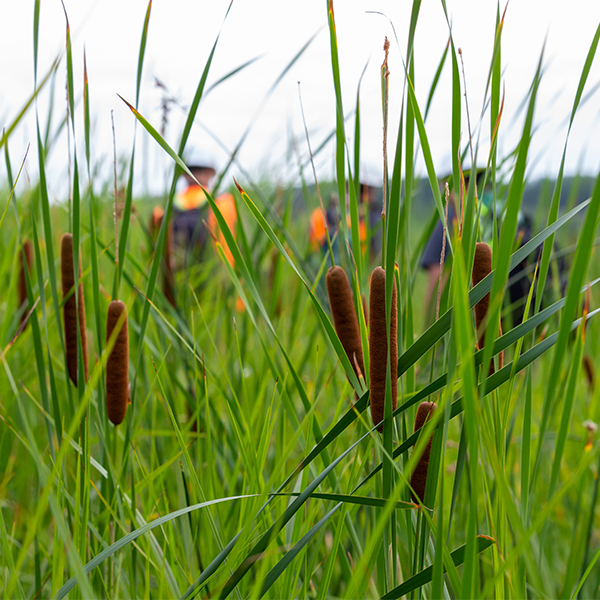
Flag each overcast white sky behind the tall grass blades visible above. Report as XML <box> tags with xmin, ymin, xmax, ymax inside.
<box><xmin>0</xmin><ymin>0</ymin><xmax>600</xmax><ymax>198</ymax></box>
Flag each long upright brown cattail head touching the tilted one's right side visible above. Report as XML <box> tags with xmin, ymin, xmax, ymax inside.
<box><xmin>369</xmin><ymin>267</ymin><xmax>398</xmax><ymax>433</ymax></box>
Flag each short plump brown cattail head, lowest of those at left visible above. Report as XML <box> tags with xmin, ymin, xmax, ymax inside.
<box><xmin>106</xmin><ymin>300</ymin><xmax>129</xmax><ymax>425</ymax></box>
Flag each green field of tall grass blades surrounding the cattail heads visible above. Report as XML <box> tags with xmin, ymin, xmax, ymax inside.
<box><xmin>0</xmin><ymin>0</ymin><xmax>600</xmax><ymax>600</ymax></box>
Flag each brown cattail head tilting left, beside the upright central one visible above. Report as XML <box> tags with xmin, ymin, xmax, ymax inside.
<box><xmin>325</xmin><ymin>267</ymin><xmax>365</xmax><ymax>380</ymax></box>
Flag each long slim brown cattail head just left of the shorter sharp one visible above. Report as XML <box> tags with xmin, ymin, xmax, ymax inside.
<box><xmin>60</xmin><ymin>233</ymin><xmax>88</xmax><ymax>385</ymax></box>
